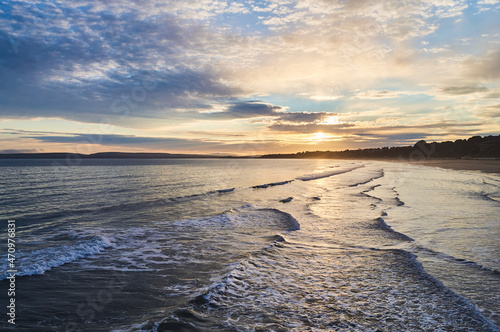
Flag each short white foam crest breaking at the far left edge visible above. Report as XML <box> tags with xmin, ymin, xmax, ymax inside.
<box><xmin>0</xmin><ymin>236</ymin><xmax>113</xmax><ymax>280</ymax></box>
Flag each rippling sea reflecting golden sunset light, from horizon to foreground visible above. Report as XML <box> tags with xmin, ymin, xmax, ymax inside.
<box><xmin>0</xmin><ymin>159</ymin><xmax>500</xmax><ymax>331</ymax></box>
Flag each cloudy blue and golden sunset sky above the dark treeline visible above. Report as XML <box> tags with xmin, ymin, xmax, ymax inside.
<box><xmin>0</xmin><ymin>0</ymin><xmax>500</xmax><ymax>155</ymax></box>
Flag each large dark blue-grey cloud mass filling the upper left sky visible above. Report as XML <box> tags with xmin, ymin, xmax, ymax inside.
<box><xmin>0</xmin><ymin>1</ymin><xmax>245</xmax><ymax>124</ymax></box>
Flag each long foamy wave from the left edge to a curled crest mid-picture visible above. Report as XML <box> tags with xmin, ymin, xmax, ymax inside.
<box><xmin>6</xmin><ymin>205</ymin><xmax>300</xmax><ymax>280</ymax></box>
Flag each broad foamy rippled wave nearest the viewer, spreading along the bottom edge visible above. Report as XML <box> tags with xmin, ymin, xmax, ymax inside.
<box><xmin>155</xmin><ymin>246</ymin><xmax>497</xmax><ymax>331</ymax></box>
